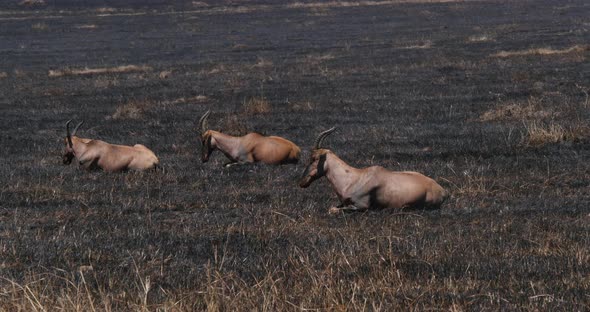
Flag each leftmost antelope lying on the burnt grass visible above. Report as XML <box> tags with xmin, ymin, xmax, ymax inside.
<box><xmin>62</xmin><ymin>120</ymin><xmax>159</xmax><ymax>172</ymax></box>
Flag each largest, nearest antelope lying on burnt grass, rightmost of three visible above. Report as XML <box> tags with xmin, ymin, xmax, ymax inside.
<box><xmin>299</xmin><ymin>128</ymin><xmax>447</xmax><ymax>214</ymax></box>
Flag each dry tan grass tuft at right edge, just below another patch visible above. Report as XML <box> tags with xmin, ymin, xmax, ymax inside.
<box><xmin>523</xmin><ymin>121</ymin><xmax>590</xmax><ymax>146</ymax></box>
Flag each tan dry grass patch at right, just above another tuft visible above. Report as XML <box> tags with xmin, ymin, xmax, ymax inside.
<box><xmin>479</xmin><ymin>97</ymin><xmax>559</xmax><ymax>121</ymax></box>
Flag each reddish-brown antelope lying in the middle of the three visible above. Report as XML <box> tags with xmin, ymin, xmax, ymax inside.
<box><xmin>199</xmin><ymin>111</ymin><xmax>301</xmax><ymax>167</ymax></box>
